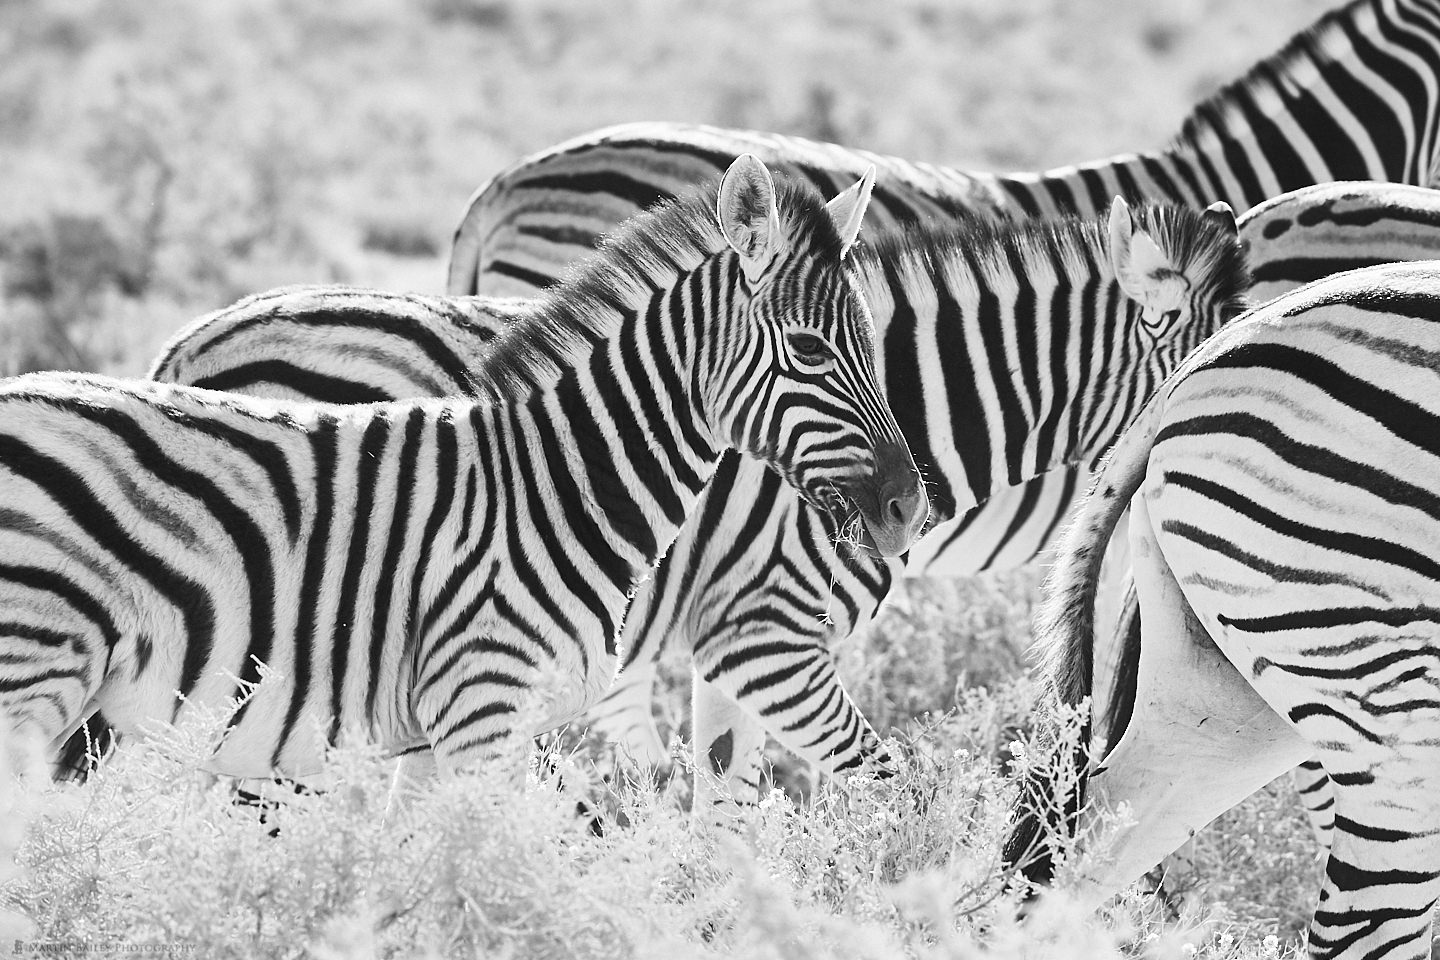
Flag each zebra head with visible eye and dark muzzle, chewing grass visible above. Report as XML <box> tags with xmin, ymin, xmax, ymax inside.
<box><xmin>700</xmin><ymin>154</ymin><xmax>930</xmax><ymax>557</ymax></box>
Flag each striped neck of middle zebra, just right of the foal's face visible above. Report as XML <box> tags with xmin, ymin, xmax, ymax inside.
<box><xmin>865</xmin><ymin>228</ymin><xmax>1138</xmax><ymax>520</ymax></box>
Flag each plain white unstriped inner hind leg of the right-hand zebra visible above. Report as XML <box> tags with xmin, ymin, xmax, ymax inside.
<box><xmin>1076</xmin><ymin>497</ymin><xmax>1312</xmax><ymax>907</ymax></box>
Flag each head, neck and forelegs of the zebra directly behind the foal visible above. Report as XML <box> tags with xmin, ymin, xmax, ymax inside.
<box><xmin>639</xmin><ymin>201</ymin><xmax>1246</xmax><ymax>817</ymax></box>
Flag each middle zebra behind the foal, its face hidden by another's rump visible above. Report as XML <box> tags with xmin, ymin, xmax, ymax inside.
<box><xmin>61</xmin><ymin>200</ymin><xmax>1244</xmax><ymax>817</ymax></box>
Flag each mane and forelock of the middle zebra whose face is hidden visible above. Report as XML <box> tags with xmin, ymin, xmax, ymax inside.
<box><xmin>855</xmin><ymin>204</ymin><xmax>1250</xmax><ymax>313</ymax></box>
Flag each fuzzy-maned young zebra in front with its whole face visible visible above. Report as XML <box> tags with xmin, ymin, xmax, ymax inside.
<box><xmin>0</xmin><ymin>157</ymin><xmax>926</xmax><ymax>777</ymax></box>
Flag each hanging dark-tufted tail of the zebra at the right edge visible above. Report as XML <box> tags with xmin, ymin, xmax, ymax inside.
<box><xmin>1002</xmin><ymin>390</ymin><xmax>1165</xmax><ymax>891</ymax></box>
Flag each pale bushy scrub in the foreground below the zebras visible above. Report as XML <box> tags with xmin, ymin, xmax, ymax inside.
<box><xmin>0</xmin><ymin>664</ymin><xmax>1319</xmax><ymax>960</ymax></box>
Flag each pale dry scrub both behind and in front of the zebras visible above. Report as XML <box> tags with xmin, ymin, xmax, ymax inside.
<box><xmin>0</xmin><ymin>0</ymin><xmax>1342</xmax><ymax>959</ymax></box>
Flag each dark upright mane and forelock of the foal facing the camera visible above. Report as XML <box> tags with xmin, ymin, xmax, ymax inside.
<box><xmin>477</xmin><ymin>176</ymin><xmax>841</xmax><ymax>400</ymax></box>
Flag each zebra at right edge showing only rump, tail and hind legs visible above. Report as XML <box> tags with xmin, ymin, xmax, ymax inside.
<box><xmin>1005</xmin><ymin>262</ymin><xmax>1440</xmax><ymax>957</ymax></box>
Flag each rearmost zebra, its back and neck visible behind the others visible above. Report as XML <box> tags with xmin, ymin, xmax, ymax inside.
<box><xmin>446</xmin><ymin>0</ymin><xmax>1440</xmax><ymax>296</ymax></box>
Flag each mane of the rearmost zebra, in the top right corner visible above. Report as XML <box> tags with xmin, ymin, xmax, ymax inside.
<box><xmin>1169</xmin><ymin>0</ymin><xmax>1375</xmax><ymax>150</ymax></box>
